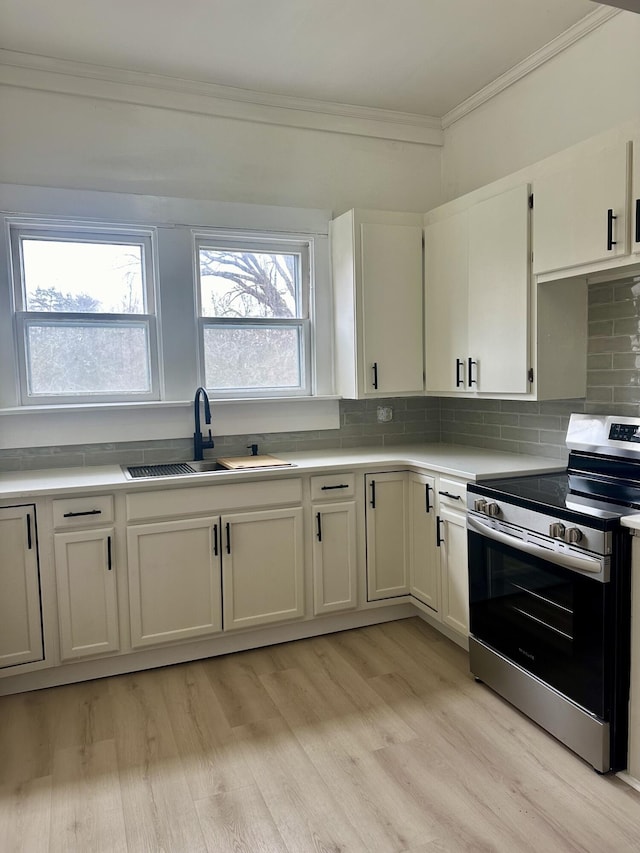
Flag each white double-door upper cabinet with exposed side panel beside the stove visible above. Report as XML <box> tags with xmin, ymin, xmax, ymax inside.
<box><xmin>425</xmin><ymin>184</ymin><xmax>587</xmax><ymax>400</ymax></box>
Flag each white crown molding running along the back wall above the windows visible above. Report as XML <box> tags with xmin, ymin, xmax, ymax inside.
<box><xmin>0</xmin><ymin>49</ymin><xmax>443</xmax><ymax>146</ymax></box>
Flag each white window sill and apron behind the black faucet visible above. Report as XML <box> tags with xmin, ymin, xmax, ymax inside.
<box><xmin>0</xmin><ymin>396</ymin><xmax>340</xmax><ymax>449</ymax></box>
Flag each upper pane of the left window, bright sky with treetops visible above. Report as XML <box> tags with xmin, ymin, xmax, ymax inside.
<box><xmin>22</xmin><ymin>237</ymin><xmax>146</xmax><ymax>314</ymax></box>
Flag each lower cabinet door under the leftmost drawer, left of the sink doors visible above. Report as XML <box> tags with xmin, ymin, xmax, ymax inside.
<box><xmin>53</xmin><ymin>528</ymin><xmax>119</xmax><ymax>660</ymax></box>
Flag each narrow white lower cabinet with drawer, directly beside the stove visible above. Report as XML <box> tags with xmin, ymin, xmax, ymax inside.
<box><xmin>437</xmin><ymin>477</ymin><xmax>469</xmax><ymax>637</ymax></box>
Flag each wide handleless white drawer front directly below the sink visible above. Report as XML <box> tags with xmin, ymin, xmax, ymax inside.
<box><xmin>127</xmin><ymin>479</ymin><xmax>302</xmax><ymax>521</ymax></box>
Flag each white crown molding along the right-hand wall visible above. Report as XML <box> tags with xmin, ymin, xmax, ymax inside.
<box><xmin>442</xmin><ymin>6</ymin><xmax>622</xmax><ymax>130</ymax></box>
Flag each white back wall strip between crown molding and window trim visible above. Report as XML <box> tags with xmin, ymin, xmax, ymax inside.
<box><xmin>0</xmin><ymin>86</ymin><xmax>442</xmax><ymax>213</ymax></box>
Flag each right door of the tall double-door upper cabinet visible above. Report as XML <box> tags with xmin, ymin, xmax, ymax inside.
<box><xmin>467</xmin><ymin>184</ymin><xmax>530</xmax><ymax>394</ymax></box>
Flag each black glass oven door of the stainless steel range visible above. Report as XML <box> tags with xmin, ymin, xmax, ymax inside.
<box><xmin>468</xmin><ymin>530</ymin><xmax>611</xmax><ymax>719</ymax></box>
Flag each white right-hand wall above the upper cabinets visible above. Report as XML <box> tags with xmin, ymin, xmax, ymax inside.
<box><xmin>442</xmin><ymin>12</ymin><xmax>640</xmax><ymax>200</ymax></box>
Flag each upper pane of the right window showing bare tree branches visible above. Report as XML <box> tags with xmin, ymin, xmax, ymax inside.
<box><xmin>199</xmin><ymin>253</ymin><xmax>301</xmax><ymax>318</ymax></box>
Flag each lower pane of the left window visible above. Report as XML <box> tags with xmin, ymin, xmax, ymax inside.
<box><xmin>26</xmin><ymin>323</ymin><xmax>151</xmax><ymax>396</ymax></box>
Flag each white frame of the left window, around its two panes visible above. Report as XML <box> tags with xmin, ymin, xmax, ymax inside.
<box><xmin>7</xmin><ymin>218</ymin><xmax>161</xmax><ymax>408</ymax></box>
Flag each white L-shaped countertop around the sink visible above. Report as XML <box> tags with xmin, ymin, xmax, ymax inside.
<box><xmin>0</xmin><ymin>444</ymin><xmax>564</xmax><ymax>502</ymax></box>
